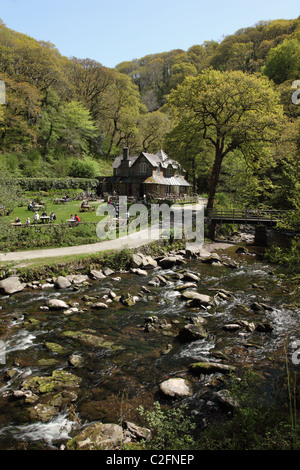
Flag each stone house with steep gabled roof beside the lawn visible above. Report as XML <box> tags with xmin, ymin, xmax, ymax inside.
<box><xmin>98</xmin><ymin>147</ymin><xmax>192</xmax><ymax>198</ymax></box>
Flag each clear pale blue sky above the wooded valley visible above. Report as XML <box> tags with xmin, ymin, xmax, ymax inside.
<box><xmin>0</xmin><ymin>0</ymin><xmax>300</xmax><ymax>67</ymax></box>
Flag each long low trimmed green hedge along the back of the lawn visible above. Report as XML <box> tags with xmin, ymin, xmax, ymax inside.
<box><xmin>0</xmin><ymin>178</ymin><xmax>98</xmax><ymax>191</ymax></box>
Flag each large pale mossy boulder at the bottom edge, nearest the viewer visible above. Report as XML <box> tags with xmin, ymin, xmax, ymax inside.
<box><xmin>66</xmin><ymin>423</ymin><xmax>123</xmax><ymax>450</ymax></box>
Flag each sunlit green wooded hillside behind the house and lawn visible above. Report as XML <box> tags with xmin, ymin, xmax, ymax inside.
<box><xmin>0</xmin><ymin>17</ymin><xmax>300</xmax><ymax>211</ymax></box>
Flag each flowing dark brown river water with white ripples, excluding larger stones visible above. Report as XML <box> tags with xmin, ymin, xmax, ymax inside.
<box><xmin>0</xmin><ymin>246</ymin><xmax>300</xmax><ymax>449</ymax></box>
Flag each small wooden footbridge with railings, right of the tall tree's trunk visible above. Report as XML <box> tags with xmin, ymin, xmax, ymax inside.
<box><xmin>205</xmin><ymin>209</ymin><xmax>290</xmax><ymax>245</ymax></box>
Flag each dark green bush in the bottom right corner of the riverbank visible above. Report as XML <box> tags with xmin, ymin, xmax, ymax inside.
<box><xmin>200</xmin><ymin>369</ymin><xmax>299</xmax><ymax>450</ymax></box>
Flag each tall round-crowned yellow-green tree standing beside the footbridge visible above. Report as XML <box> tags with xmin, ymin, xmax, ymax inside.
<box><xmin>169</xmin><ymin>69</ymin><xmax>283</xmax><ymax>209</ymax></box>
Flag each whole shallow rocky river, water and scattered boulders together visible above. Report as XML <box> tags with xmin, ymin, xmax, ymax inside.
<box><xmin>0</xmin><ymin>241</ymin><xmax>300</xmax><ymax>450</ymax></box>
